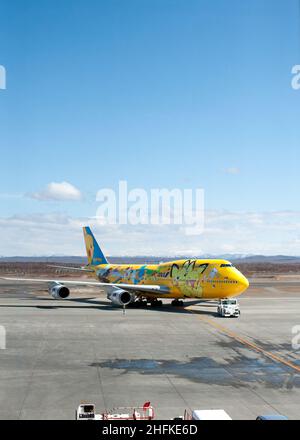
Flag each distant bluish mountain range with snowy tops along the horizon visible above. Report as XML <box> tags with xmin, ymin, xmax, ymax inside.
<box><xmin>0</xmin><ymin>254</ymin><xmax>300</xmax><ymax>265</ymax></box>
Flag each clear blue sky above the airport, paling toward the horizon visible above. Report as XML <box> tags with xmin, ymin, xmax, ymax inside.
<box><xmin>0</xmin><ymin>0</ymin><xmax>300</xmax><ymax>255</ymax></box>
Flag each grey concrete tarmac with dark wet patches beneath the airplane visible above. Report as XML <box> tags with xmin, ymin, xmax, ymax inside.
<box><xmin>0</xmin><ymin>280</ymin><xmax>300</xmax><ymax>419</ymax></box>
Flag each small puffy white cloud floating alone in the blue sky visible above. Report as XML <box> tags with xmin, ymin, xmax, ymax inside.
<box><xmin>28</xmin><ymin>182</ymin><xmax>82</xmax><ymax>201</ymax></box>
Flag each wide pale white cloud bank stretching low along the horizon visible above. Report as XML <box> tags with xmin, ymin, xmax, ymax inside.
<box><xmin>0</xmin><ymin>211</ymin><xmax>300</xmax><ymax>257</ymax></box>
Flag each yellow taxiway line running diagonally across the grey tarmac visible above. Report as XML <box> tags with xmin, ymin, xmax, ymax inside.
<box><xmin>186</xmin><ymin>307</ymin><xmax>300</xmax><ymax>373</ymax></box>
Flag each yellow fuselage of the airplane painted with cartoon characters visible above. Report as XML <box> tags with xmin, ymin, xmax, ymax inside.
<box><xmin>93</xmin><ymin>259</ymin><xmax>249</xmax><ymax>299</ymax></box>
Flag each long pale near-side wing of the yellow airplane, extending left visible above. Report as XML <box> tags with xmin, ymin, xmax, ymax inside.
<box><xmin>0</xmin><ymin>277</ymin><xmax>169</xmax><ymax>294</ymax></box>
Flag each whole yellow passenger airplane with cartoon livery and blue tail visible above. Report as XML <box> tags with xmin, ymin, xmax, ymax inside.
<box><xmin>1</xmin><ymin>226</ymin><xmax>249</xmax><ymax>306</ymax></box>
